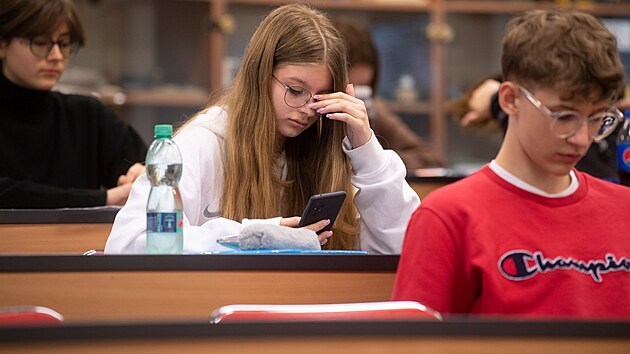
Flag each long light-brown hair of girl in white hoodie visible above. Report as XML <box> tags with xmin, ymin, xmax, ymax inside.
<box><xmin>218</xmin><ymin>4</ymin><xmax>359</xmax><ymax>249</ymax></box>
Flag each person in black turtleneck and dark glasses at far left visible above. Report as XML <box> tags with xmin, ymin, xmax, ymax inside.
<box><xmin>0</xmin><ymin>0</ymin><xmax>147</xmax><ymax>208</ymax></box>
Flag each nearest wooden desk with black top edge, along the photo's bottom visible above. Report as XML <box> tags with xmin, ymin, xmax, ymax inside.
<box><xmin>0</xmin><ymin>319</ymin><xmax>630</xmax><ymax>354</ymax></box>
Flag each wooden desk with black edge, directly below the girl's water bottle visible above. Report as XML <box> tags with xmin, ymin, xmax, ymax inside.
<box><xmin>0</xmin><ymin>254</ymin><xmax>398</xmax><ymax>323</ymax></box>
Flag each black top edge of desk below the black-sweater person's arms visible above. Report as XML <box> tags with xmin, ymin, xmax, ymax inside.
<box><xmin>0</xmin><ymin>207</ymin><xmax>120</xmax><ymax>224</ymax></box>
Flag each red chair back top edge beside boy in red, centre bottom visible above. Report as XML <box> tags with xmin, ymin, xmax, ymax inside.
<box><xmin>210</xmin><ymin>301</ymin><xmax>442</xmax><ymax>323</ymax></box>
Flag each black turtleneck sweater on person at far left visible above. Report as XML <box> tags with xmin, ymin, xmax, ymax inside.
<box><xmin>0</xmin><ymin>74</ymin><xmax>147</xmax><ymax>208</ymax></box>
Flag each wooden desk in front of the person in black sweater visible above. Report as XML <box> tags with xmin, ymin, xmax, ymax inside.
<box><xmin>0</xmin><ymin>208</ymin><xmax>119</xmax><ymax>254</ymax></box>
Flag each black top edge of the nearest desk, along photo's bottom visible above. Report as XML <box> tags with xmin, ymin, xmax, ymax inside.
<box><xmin>0</xmin><ymin>319</ymin><xmax>630</xmax><ymax>343</ymax></box>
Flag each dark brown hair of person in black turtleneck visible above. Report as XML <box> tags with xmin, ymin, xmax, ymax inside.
<box><xmin>0</xmin><ymin>0</ymin><xmax>85</xmax><ymax>46</ymax></box>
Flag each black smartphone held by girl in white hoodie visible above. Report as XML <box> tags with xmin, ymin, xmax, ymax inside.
<box><xmin>298</xmin><ymin>191</ymin><xmax>346</xmax><ymax>233</ymax></box>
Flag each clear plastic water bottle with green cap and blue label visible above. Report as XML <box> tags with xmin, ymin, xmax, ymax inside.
<box><xmin>146</xmin><ymin>125</ymin><xmax>184</xmax><ymax>254</ymax></box>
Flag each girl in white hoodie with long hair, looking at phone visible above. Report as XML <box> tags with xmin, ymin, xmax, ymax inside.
<box><xmin>105</xmin><ymin>4</ymin><xmax>420</xmax><ymax>253</ymax></box>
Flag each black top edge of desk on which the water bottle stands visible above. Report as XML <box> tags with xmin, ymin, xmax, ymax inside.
<box><xmin>0</xmin><ymin>254</ymin><xmax>399</xmax><ymax>272</ymax></box>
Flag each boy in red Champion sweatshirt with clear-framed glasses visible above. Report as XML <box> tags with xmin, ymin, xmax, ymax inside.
<box><xmin>392</xmin><ymin>9</ymin><xmax>630</xmax><ymax>319</ymax></box>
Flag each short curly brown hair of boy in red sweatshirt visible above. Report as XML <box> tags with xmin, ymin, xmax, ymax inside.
<box><xmin>501</xmin><ymin>8</ymin><xmax>625</xmax><ymax>101</ymax></box>
